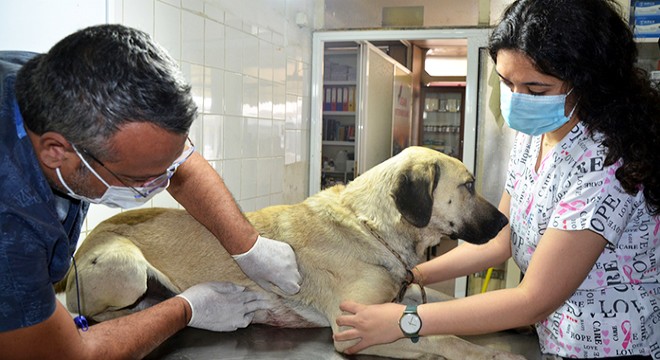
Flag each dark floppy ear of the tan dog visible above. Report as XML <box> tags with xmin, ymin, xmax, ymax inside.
<box><xmin>392</xmin><ymin>164</ymin><xmax>440</xmax><ymax>228</ymax></box>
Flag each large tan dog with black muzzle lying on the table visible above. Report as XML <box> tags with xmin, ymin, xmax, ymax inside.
<box><xmin>59</xmin><ymin>147</ymin><xmax>519</xmax><ymax>359</ymax></box>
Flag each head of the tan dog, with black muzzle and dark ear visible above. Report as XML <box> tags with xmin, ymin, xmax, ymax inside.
<box><xmin>392</xmin><ymin>150</ymin><xmax>508</xmax><ymax>244</ymax></box>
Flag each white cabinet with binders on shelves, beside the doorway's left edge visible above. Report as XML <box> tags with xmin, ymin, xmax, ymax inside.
<box><xmin>310</xmin><ymin>41</ymin><xmax>412</xmax><ymax>194</ymax></box>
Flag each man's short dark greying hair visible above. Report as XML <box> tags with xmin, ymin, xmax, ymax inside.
<box><xmin>16</xmin><ymin>25</ymin><xmax>197</xmax><ymax>157</ymax></box>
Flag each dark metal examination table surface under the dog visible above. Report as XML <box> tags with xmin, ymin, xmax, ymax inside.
<box><xmin>146</xmin><ymin>325</ymin><xmax>541</xmax><ymax>360</ymax></box>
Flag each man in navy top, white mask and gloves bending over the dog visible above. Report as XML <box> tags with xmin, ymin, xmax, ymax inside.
<box><xmin>0</xmin><ymin>25</ymin><xmax>301</xmax><ymax>359</ymax></box>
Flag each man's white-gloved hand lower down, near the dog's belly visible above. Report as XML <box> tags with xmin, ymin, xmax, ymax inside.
<box><xmin>177</xmin><ymin>282</ymin><xmax>268</xmax><ymax>331</ymax></box>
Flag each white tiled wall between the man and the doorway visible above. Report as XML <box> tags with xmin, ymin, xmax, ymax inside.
<box><xmin>82</xmin><ymin>0</ymin><xmax>314</xmax><ymax>238</ymax></box>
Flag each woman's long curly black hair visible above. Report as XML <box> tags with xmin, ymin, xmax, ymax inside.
<box><xmin>489</xmin><ymin>0</ymin><xmax>660</xmax><ymax>215</ymax></box>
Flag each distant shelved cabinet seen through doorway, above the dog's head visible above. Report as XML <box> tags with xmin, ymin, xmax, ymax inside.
<box><xmin>419</xmin><ymin>86</ymin><xmax>465</xmax><ymax>160</ymax></box>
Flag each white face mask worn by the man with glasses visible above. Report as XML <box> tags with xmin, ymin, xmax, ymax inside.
<box><xmin>55</xmin><ymin>148</ymin><xmax>170</xmax><ymax>209</ymax></box>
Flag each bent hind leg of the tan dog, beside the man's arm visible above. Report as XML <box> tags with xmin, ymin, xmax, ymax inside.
<box><xmin>66</xmin><ymin>237</ymin><xmax>179</xmax><ymax>321</ymax></box>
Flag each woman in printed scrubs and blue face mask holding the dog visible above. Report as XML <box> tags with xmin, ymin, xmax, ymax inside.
<box><xmin>335</xmin><ymin>0</ymin><xmax>660</xmax><ymax>359</ymax></box>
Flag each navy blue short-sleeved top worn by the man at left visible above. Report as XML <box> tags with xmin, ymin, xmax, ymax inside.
<box><xmin>0</xmin><ymin>51</ymin><xmax>89</xmax><ymax>331</ymax></box>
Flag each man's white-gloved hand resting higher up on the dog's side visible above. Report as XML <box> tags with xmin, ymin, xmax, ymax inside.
<box><xmin>232</xmin><ymin>235</ymin><xmax>302</xmax><ymax>295</ymax></box>
